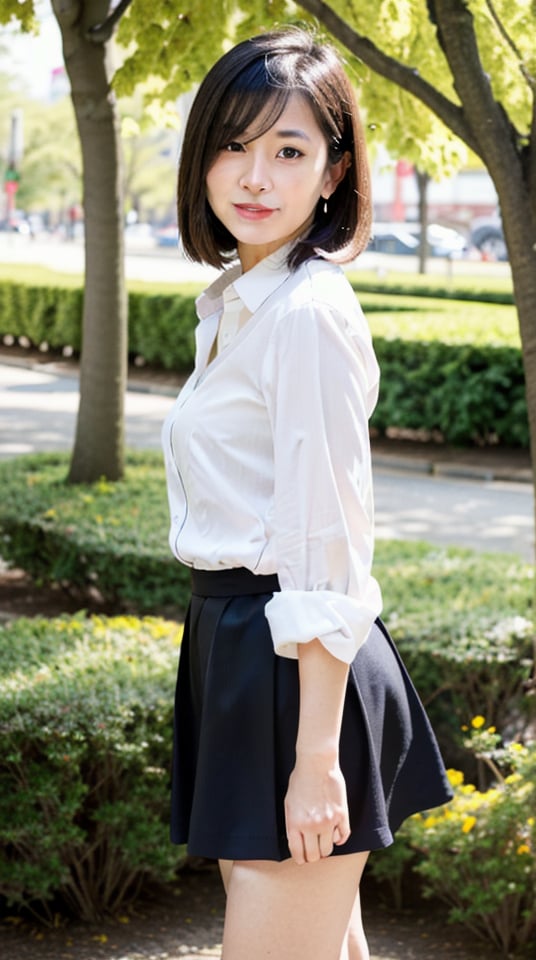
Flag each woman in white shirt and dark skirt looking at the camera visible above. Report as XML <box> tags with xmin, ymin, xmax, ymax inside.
<box><xmin>163</xmin><ymin>29</ymin><xmax>450</xmax><ymax>960</ymax></box>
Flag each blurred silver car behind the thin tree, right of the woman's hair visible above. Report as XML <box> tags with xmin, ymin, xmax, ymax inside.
<box><xmin>367</xmin><ymin>223</ymin><xmax>469</xmax><ymax>258</ymax></box>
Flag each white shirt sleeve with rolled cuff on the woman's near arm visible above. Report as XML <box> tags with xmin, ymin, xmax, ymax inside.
<box><xmin>262</xmin><ymin>303</ymin><xmax>381</xmax><ymax>663</ymax></box>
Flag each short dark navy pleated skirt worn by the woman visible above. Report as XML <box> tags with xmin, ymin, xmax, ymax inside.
<box><xmin>171</xmin><ymin>569</ymin><xmax>452</xmax><ymax>860</ymax></box>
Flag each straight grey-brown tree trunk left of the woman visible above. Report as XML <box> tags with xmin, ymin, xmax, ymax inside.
<box><xmin>53</xmin><ymin>0</ymin><xmax>127</xmax><ymax>483</ymax></box>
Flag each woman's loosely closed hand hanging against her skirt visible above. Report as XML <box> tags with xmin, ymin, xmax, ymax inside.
<box><xmin>285</xmin><ymin>756</ymin><xmax>350</xmax><ymax>864</ymax></box>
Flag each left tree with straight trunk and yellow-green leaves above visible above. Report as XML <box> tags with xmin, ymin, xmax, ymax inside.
<box><xmin>0</xmin><ymin>0</ymin><xmax>288</xmax><ymax>482</ymax></box>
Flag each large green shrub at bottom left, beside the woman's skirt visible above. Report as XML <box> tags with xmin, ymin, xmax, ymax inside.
<box><xmin>0</xmin><ymin>615</ymin><xmax>180</xmax><ymax>920</ymax></box>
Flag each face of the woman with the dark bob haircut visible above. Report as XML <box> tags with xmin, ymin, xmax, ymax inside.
<box><xmin>206</xmin><ymin>94</ymin><xmax>346</xmax><ymax>271</ymax></box>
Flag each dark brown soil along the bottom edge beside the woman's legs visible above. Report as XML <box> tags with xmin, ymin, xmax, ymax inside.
<box><xmin>0</xmin><ymin>864</ymin><xmax>499</xmax><ymax>960</ymax></box>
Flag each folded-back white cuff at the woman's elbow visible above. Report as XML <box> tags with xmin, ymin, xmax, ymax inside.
<box><xmin>265</xmin><ymin>577</ymin><xmax>382</xmax><ymax>663</ymax></box>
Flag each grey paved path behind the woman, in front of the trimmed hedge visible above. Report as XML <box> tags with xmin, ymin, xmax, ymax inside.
<box><xmin>0</xmin><ymin>365</ymin><xmax>534</xmax><ymax>561</ymax></box>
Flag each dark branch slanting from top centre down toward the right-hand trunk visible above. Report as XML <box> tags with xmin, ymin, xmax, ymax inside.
<box><xmin>299</xmin><ymin>0</ymin><xmax>480</xmax><ymax>155</ymax></box>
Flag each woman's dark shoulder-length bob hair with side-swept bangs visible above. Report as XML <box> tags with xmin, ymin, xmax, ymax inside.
<box><xmin>177</xmin><ymin>27</ymin><xmax>372</xmax><ymax>268</ymax></box>
